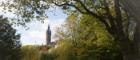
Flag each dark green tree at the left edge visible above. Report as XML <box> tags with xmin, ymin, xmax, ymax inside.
<box><xmin>0</xmin><ymin>16</ymin><xmax>21</xmax><ymax>60</ymax></box>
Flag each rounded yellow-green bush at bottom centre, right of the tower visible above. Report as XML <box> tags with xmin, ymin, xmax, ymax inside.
<box><xmin>51</xmin><ymin>40</ymin><xmax>76</xmax><ymax>60</ymax></box>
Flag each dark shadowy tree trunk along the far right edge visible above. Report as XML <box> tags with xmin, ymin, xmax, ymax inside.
<box><xmin>122</xmin><ymin>0</ymin><xmax>140</xmax><ymax>60</ymax></box>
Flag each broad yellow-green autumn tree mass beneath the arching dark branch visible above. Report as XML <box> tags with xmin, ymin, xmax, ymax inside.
<box><xmin>54</xmin><ymin>13</ymin><xmax>122</xmax><ymax>60</ymax></box>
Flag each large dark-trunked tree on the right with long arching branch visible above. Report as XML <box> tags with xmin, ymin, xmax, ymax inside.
<box><xmin>46</xmin><ymin>0</ymin><xmax>140</xmax><ymax>60</ymax></box>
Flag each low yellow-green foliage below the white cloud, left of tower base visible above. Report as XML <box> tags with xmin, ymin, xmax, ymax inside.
<box><xmin>21</xmin><ymin>45</ymin><xmax>56</xmax><ymax>60</ymax></box>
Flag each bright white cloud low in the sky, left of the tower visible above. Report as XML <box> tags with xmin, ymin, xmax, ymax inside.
<box><xmin>21</xmin><ymin>30</ymin><xmax>45</xmax><ymax>45</ymax></box>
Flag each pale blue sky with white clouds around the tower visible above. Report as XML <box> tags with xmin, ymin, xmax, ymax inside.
<box><xmin>0</xmin><ymin>0</ymin><xmax>67</xmax><ymax>45</ymax></box>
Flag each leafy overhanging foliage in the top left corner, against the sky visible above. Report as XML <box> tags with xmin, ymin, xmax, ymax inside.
<box><xmin>0</xmin><ymin>0</ymin><xmax>49</xmax><ymax>25</ymax></box>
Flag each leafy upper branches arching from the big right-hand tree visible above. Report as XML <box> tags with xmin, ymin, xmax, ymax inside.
<box><xmin>52</xmin><ymin>0</ymin><xmax>127</xmax><ymax>36</ymax></box>
